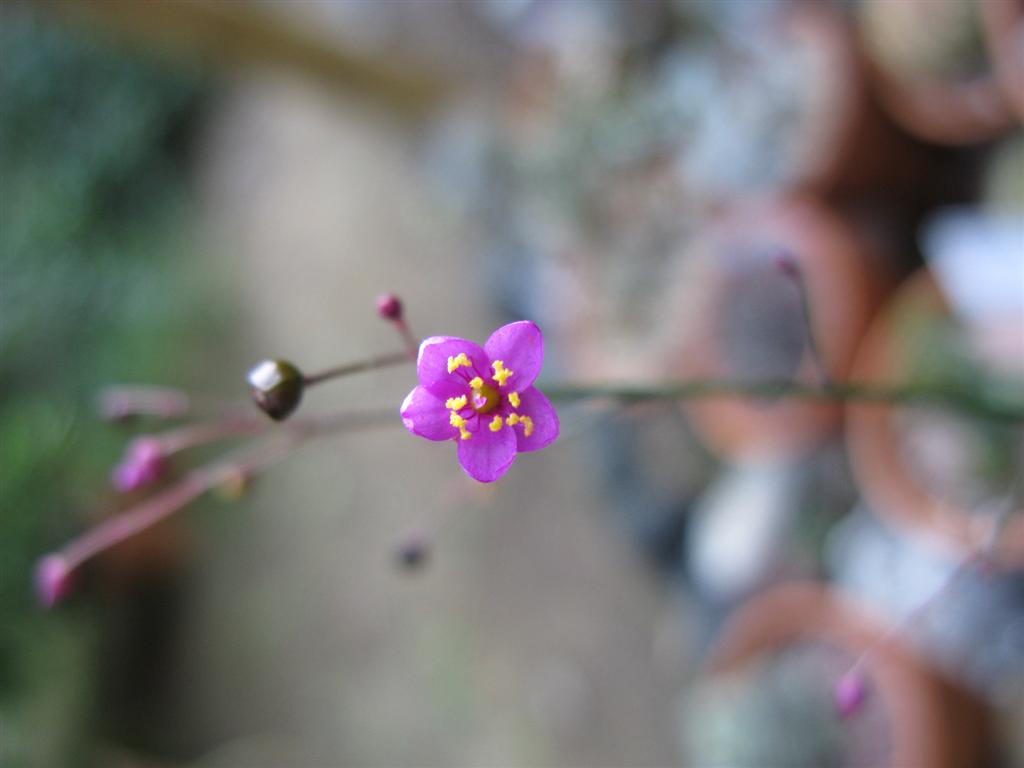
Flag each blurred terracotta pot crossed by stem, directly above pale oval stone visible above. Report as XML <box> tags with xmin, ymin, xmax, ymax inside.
<box><xmin>673</xmin><ymin>199</ymin><xmax>878</xmax><ymax>457</ymax></box>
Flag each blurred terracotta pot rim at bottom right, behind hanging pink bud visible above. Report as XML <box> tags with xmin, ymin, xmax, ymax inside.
<box><xmin>709</xmin><ymin>584</ymin><xmax>989</xmax><ymax>768</ymax></box>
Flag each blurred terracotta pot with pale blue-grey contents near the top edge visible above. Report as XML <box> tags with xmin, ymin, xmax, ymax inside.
<box><xmin>677</xmin><ymin>3</ymin><xmax>911</xmax><ymax>203</ymax></box>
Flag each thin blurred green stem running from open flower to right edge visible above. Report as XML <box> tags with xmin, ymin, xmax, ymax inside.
<box><xmin>541</xmin><ymin>379</ymin><xmax>1024</xmax><ymax>423</ymax></box>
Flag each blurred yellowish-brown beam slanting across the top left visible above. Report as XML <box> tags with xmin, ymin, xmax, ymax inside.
<box><xmin>41</xmin><ymin>0</ymin><xmax>451</xmax><ymax>117</ymax></box>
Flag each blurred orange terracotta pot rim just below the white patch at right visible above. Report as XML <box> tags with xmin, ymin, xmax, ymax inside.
<box><xmin>847</xmin><ymin>270</ymin><xmax>1024</xmax><ymax>566</ymax></box>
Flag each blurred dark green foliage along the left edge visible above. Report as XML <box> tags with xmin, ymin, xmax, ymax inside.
<box><xmin>0</xmin><ymin>4</ymin><xmax>206</xmax><ymax>766</ymax></box>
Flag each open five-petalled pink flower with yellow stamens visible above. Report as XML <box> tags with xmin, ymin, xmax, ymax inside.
<box><xmin>401</xmin><ymin>321</ymin><xmax>558</xmax><ymax>482</ymax></box>
